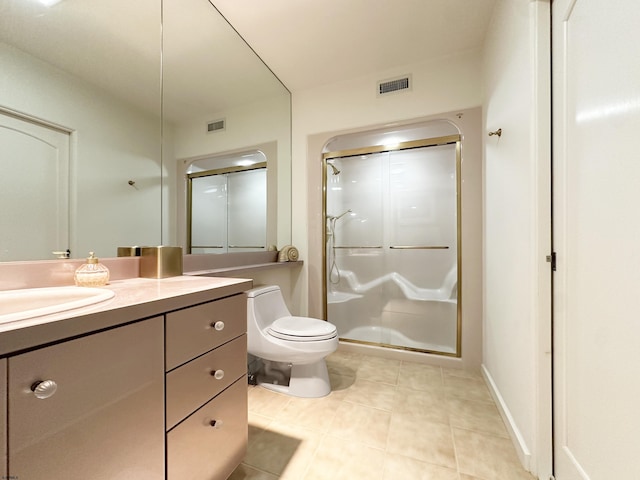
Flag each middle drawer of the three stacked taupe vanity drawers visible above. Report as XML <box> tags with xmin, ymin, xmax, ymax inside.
<box><xmin>166</xmin><ymin>335</ymin><xmax>247</xmax><ymax>429</ymax></box>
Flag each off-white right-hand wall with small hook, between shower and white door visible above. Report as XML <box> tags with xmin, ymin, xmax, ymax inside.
<box><xmin>483</xmin><ymin>0</ymin><xmax>551</xmax><ymax>478</ymax></box>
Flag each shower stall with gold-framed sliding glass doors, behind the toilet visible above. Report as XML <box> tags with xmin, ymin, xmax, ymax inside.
<box><xmin>323</xmin><ymin>135</ymin><xmax>461</xmax><ymax>357</ymax></box>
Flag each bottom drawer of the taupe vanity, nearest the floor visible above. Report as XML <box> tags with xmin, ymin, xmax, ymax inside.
<box><xmin>167</xmin><ymin>379</ymin><xmax>248</xmax><ymax>480</ymax></box>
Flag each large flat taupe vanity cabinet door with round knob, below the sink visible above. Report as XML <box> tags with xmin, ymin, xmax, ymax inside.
<box><xmin>7</xmin><ymin>317</ymin><xmax>165</xmax><ymax>480</ymax></box>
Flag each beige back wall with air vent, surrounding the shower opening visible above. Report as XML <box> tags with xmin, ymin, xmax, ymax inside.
<box><xmin>292</xmin><ymin>52</ymin><xmax>481</xmax><ymax>366</ymax></box>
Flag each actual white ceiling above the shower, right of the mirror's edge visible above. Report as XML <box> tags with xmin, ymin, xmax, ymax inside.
<box><xmin>210</xmin><ymin>0</ymin><xmax>496</xmax><ymax>91</ymax></box>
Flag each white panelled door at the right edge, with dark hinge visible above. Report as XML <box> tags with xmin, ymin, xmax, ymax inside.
<box><xmin>552</xmin><ymin>0</ymin><xmax>640</xmax><ymax>480</ymax></box>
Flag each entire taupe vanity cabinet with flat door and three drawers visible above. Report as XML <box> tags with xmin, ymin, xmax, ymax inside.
<box><xmin>0</xmin><ymin>279</ymin><xmax>251</xmax><ymax>480</ymax></box>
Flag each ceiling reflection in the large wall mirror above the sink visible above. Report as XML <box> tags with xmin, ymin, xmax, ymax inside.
<box><xmin>0</xmin><ymin>0</ymin><xmax>284</xmax><ymax>122</ymax></box>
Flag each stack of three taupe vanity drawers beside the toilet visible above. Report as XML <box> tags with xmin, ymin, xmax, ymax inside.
<box><xmin>166</xmin><ymin>295</ymin><xmax>248</xmax><ymax>480</ymax></box>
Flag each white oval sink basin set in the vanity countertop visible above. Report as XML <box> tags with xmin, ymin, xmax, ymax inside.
<box><xmin>0</xmin><ymin>287</ymin><xmax>115</xmax><ymax>324</ymax></box>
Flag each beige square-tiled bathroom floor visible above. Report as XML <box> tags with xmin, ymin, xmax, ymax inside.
<box><xmin>230</xmin><ymin>351</ymin><xmax>533</xmax><ymax>480</ymax></box>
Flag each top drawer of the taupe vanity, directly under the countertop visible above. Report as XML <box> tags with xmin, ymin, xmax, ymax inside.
<box><xmin>165</xmin><ymin>294</ymin><xmax>247</xmax><ymax>371</ymax></box>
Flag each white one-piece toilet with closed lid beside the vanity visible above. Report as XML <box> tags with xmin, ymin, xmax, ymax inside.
<box><xmin>246</xmin><ymin>285</ymin><xmax>338</xmax><ymax>398</ymax></box>
